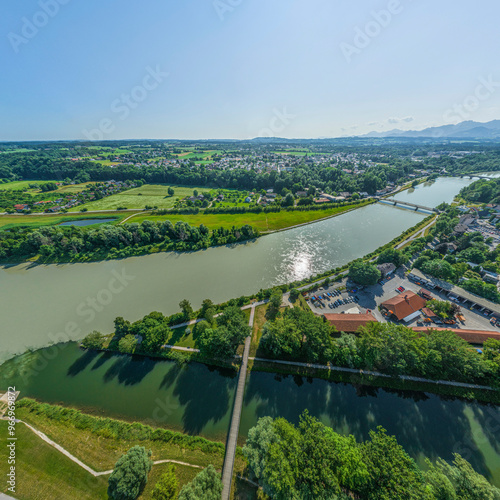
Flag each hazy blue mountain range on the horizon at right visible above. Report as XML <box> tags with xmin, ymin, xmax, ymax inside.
<box><xmin>360</xmin><ymin>120</ymin><xmax>500</xmax><ymax>139</ymax></box>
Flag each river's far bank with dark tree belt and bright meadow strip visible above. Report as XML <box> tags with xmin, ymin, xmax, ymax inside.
<box><xmin>0</xmin><ymin>199</ymin><xmax>375</xmax><ymax>264</ymax></box>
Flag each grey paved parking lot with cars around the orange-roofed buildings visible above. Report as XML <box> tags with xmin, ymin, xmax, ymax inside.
<box><xmin>308</xmin><ymin>268</ymin><xmax>498</xmax><ymax>331</ymax></box>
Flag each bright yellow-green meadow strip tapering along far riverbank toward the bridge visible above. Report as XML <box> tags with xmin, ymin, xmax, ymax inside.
<box><xmin>128</xmin><ymin>205</ymin><xmax>372</xmax><ymax>232</ymax></box>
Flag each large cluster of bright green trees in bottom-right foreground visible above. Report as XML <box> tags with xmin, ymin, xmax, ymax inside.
<box><xmin>243</xmin><ymin>411</ymin><xmax>500</xmax><ymax>500</ymax></box>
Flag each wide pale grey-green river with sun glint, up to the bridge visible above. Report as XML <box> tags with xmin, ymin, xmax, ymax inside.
<box><xmin>0</xmin><ymin>204</ymin><xmax>425</xmax><ymax>362</ymax></box>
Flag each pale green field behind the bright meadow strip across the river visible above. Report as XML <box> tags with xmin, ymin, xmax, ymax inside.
<box><xmin>70</xmin><ymin>184</ymin><xmax>207</xmax><ymax>212</ymax></box>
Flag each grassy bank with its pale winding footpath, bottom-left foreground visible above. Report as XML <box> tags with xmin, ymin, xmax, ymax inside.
<box><xmin>0</xmin><ymin>398</ymin><xmax>254</xmax><ymax>500</ymax></box>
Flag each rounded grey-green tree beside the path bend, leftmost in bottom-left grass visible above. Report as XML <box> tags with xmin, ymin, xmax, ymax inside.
<box><xmin>108</xmin><ymin>446</ymin><xmax>152</xmax><ymax>500</ymax></box>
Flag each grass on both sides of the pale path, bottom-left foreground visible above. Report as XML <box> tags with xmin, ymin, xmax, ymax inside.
<box><xmin>0</xmin><ymin>402</ymin><xmax>256</xmax><ymax>500</ymax></box>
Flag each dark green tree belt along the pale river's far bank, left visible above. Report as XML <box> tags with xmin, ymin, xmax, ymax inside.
<box><xmin>0</xmin><ymin>220</ymin><xmax>258</xmax><ymax>261</ymax></box>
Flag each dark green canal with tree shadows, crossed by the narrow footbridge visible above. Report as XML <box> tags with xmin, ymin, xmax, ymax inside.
<box><xmin>0</xmin><ymin>342</ymin><xmax>500</xmax><ymax>485</ymax></box>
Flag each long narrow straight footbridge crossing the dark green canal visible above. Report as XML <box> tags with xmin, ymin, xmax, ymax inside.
<box><xmin>222</xmin><ymin>303</ymin><xmax>258</xmax><ymax>500</ymax></box>
